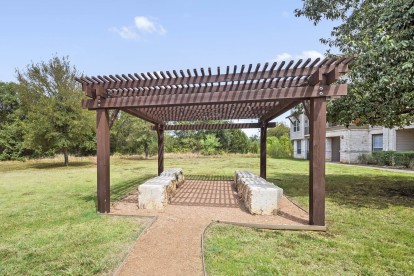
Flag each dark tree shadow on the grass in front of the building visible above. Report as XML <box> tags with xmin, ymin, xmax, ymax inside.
<box><xmin>268</xmin><ymin>170</ymin><xmax>414</xmax><ymax>209</ymax></box>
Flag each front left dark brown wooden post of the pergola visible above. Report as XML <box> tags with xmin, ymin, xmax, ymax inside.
<box><xmin>96</xmin><ymin>109</ymin><xmax>111</xmax><ymax>213</ymax></box>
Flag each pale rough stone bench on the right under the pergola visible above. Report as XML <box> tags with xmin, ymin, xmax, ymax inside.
<box><xmin>234</xmin><ymin>171</ymin><xmax>283</xmax><ymax>215</ymax></box>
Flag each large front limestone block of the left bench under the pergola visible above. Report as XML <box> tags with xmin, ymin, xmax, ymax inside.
<box><xmin>138</xmin><ymin>176</ymin><xmax>177</xmax><ymax>209</ymax></box>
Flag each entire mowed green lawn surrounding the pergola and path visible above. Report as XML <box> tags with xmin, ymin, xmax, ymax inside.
<box><xmin>0</xmin><ymin>155</ymin><xmax>414</xmax><ymax>275</ymax></box>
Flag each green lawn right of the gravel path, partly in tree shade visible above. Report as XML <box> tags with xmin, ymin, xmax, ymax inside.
<box><xmin>205</xmin><ymin>160</ymin><xmax>414</xmax><ymax>275</ymax></box>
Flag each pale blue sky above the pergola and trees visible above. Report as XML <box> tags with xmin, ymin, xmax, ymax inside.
<box><xmin>0</xmin><ymin>0</ymin><xmax>333</xmax><ymax>136</ymax></box>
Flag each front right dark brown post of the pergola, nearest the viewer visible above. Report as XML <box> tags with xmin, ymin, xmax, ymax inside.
<box><xmin>309</xmin><ymin>97</ymin><xmax>326</xmax><ymax>226</ymax></box>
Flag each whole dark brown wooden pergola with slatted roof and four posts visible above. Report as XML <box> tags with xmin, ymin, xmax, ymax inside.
<box><xmin>77</xmin><ymin>57</ymin><xmax>352</xmax><ymax>225</ymax></box>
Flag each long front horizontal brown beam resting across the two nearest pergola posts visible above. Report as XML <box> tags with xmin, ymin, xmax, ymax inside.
<box><xmin>82</xmin><ymin>84</ymin><xmax>347</xmax><ymax>109</ymax></box>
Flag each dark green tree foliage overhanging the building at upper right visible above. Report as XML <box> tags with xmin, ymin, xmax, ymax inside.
<box><xmin>295</xmin><ymin>0</ymin><xmax>414</xmax><ymax>127</ymax></box>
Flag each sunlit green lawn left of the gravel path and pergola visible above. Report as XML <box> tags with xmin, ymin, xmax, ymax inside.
<box><xmin>0</xmin><ymin>158</ymin><xmax>154</xmax><ymax>275</ymax></box>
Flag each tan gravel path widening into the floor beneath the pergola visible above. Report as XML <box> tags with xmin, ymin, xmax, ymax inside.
<box><xmin>112</xmin><ymin>180</ymin><xmax>308</xmax><ymax>275</ymax></box>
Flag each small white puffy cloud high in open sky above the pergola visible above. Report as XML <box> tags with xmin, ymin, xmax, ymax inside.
<box><xmin>109</xmin><ymin>16</ymin><xmax>167</xmax><ymax>40</ymax></box>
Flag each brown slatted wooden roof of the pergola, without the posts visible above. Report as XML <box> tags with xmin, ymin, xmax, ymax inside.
<box><xmin>77</xmin><ymin>57</ymin><xmax>353</xmax><ymax>124</ymax></box>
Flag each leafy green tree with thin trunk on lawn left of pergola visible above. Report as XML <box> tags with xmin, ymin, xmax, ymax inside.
<box><xmin>17</xmin><ymin>57</ymin><xmax>95</xmax><ymax>166</ymax></box>
